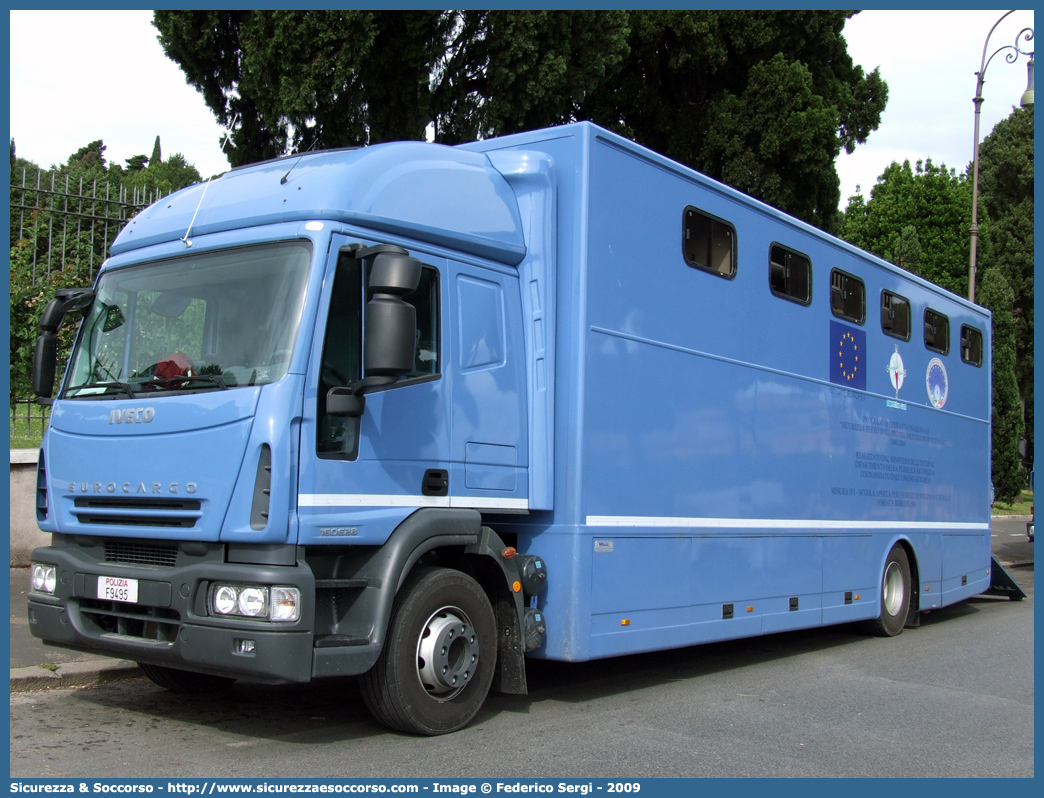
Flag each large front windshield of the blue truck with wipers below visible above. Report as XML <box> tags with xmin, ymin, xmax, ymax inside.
<box><xmin>63</xmin><ymin>241</ymin><xmax>311</xmax><ymax>398</ymax></box>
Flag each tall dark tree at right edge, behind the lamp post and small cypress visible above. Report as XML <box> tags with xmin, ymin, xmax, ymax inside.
<box><xmin>979</xmin><ymin>109</ymin><xmax>1034</xmax><ymax>467</ymax></box>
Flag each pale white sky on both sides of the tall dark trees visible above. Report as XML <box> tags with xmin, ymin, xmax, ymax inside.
<box><xmin>10</xmin><ymin>10</ymin><xmax>1034</xmax><ymax>205</ymax></box>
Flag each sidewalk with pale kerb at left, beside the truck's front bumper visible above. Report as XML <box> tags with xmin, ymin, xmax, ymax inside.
<box><xmin>10</xmin><ymin>568</ymin><xmax>142</xmax><ymax>693</ymax></box>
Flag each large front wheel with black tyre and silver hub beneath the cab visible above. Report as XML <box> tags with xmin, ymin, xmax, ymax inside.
<box><xmin>361</xmin><ymin>568</ymin><xmax>497</xmax><ymax>735</ymax></box>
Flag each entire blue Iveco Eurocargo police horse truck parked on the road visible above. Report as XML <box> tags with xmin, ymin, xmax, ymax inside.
<box><xmin>28</xmin><ymin>123</ymin><xmax>1014</xmax><ymax>734</ymax></box>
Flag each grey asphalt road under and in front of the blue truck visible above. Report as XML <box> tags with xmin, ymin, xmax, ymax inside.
<box><xmin>10</xmin><ymin>522</ymin><xmax>1034</xmax><ymax>778</ymax></box>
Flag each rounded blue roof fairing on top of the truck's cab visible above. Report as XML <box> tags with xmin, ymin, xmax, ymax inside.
<box><xmin>112</xmin><ymin>141</ymin><xmax>525</xmax><ymax>265</ymax></box>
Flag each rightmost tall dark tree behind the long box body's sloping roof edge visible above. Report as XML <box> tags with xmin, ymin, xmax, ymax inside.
<box><xmin>585</xmin><ymin>10</ymin><xmax>887</xmax><ymax>230</ymax></box>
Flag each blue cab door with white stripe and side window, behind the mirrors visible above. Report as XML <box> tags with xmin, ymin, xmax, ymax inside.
<box><xmin>298</xmin><ymin>236</ymin><xmax>450</xmax><ymax>545</ymax></box>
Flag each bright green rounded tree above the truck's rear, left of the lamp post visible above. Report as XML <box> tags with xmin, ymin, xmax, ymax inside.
<box><xmin>839</xmin><ymin>159</ymin><xmax>973</xmax><ymax>296</ymax></box>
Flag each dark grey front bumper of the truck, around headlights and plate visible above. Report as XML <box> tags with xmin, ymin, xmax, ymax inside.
<box><xmin>28</xmin><ymin>535</ymin><xmax>315</xmax><ymax>683</ymax></box>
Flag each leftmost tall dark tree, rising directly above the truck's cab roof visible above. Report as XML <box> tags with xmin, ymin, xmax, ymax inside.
<box><xmin>153</xmin><ymin>10</ymin><xmax>451</xmax><ymax>165</ymax></box>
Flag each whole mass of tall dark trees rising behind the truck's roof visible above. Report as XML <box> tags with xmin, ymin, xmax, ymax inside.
<box><xmin>153</xmin><ymin>10</ymin><xmax>887</xmax><ymax>230</ymax></box>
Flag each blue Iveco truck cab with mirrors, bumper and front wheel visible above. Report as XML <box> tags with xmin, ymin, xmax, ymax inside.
<box><xmin>29</xmin><ymin>138</ymin><xmax>544</xmax><ymax>733</ymax></box>
